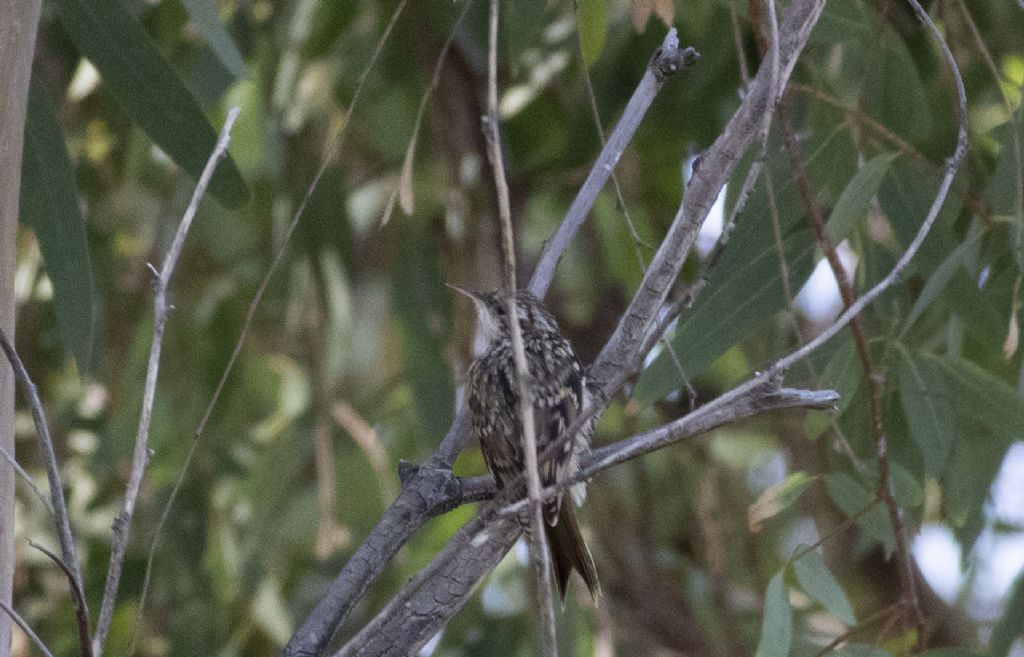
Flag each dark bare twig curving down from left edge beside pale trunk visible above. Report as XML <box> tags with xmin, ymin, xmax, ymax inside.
<box><xmin>0</xmin><ymin>330</ymin><xmax>89</xmax><ymax>618</ymax></box>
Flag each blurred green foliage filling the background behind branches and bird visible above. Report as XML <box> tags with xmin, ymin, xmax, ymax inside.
<box><xmin>6</xmin><ymin>0</ymin><xmax>1024</xmax><ymax>657</ymax></box>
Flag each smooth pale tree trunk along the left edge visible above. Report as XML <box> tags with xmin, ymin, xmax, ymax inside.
<box><xmin>0</xmin><ymin>0</ymin><xmax>41</xmax><ymax>657</ymax></box>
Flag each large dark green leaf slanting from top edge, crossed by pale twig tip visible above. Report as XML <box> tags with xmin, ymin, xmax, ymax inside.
<box><xmin>56</xmin><ymin>0</ymin><xmax>249</xmax><ymax>208</ymax></box>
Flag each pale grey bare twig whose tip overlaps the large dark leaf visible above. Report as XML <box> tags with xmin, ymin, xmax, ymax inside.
<box><xmin>92</xmin><ymin>107</ymin><xmax>241</xmax><ymax>657</ymax></box>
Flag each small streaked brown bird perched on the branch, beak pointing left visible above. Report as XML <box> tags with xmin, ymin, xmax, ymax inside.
<box><xmin>453</xmin><ymin>286</ymin><xmax>601</xmax><ymax>601</ymax></box>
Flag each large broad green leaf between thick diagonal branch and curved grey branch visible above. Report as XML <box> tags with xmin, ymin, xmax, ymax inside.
<box><xmin>633</xmin><ymin>216</ymin><xmax>814</xmax><ymax>401</ymax></box>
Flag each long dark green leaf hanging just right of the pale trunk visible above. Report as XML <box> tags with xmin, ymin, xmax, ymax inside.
<box><xmin>20</xmin><ymin>81</ymin><xmax>92</xmax><ymax>373</ymax></box>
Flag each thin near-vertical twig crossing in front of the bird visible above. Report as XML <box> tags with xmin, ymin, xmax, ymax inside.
<box><xmin>484</xmin><ymin>0</ymin><xmax>557</xmax><ymax>657</ymax></box>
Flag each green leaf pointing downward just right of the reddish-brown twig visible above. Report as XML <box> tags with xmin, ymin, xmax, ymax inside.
<box><xmin>898</xmin><ymin>349</ymin><xmax>955</xmax><ymax>475</ymax></box>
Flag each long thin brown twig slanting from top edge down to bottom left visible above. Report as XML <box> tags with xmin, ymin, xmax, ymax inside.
<box><xmin>138</xmin><ymin>0</ymin><xmax>409</xmax><ymax>646</ymax></box>
